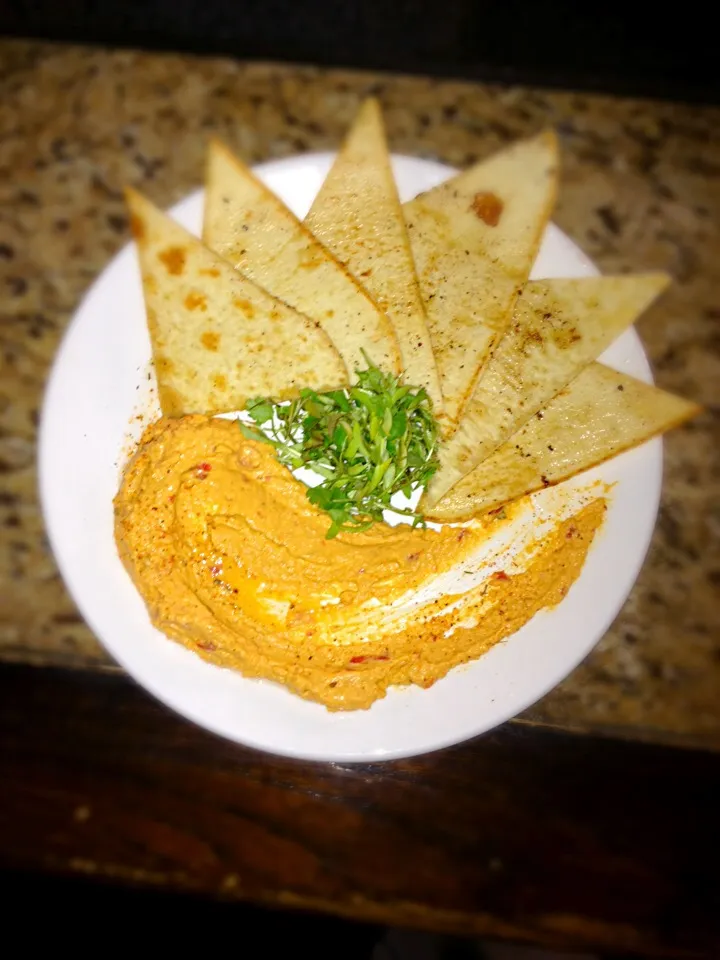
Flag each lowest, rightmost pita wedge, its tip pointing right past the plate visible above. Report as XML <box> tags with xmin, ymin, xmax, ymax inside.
<box><xmin>426</xmin><ymin>363</ymin><xmax>701</xmax><ymax>522</ymax></box>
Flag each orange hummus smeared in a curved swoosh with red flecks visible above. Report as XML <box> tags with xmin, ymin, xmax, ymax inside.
<box><xmin>115</xmin><ymin>416</ymin><xmax>605</xmax><ymax>710</ymax></box>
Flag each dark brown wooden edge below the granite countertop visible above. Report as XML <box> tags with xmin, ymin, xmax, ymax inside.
<box><xmin>0</xmin><ymin>664</ymin><xmax>720</xmax><ymax>957</ymax></box>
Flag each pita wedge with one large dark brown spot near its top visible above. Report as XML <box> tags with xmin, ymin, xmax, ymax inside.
<box><xmin>403</xmin><ymin>132</ymin><xmax>558</xmax><ymax>435</ymax></box>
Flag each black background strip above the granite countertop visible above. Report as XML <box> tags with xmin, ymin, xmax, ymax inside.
<box><xmin>0</xmin><ymin>0</ymin><xmax>720</xmax><ymax>103</ymax></box>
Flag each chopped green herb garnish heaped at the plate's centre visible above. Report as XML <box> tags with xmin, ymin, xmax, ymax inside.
<box><xmin>238</xmin><ymin>357</ymin><xmax>438</xmax><ymax>539</ymax></box>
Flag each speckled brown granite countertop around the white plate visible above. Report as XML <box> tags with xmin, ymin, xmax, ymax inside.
<box><xmin>0</xmin><ymin>41</ymin><xmax>720</xmax><ymax>748</ymax></box>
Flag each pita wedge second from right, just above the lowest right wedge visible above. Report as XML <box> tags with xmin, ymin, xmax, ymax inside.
<box><xmin>421</xmin><ymin>274</ymin><xmax>669</xmax><ymax>509</ymax></box>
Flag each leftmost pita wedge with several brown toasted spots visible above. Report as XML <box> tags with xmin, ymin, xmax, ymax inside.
<box><xmin>127</xmin><ymin>190</ymin><xmax>348</xmax><ymax>416</ymax></box>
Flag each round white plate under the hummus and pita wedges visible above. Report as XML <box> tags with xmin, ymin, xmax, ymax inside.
<box><xmin>39</xmin><ymin>154</ymin><xmax>662</xmax><ymax>761</ymax></box>
